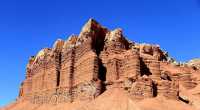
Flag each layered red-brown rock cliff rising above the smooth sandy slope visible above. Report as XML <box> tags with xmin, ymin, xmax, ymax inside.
<box><xmin>11</xmin><ymin>19</ymin><xmax>200</xmax><ymax>108</ymax></box>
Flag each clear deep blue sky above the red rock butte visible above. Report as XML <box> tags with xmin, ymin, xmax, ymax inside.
<box><xmin>0</xmin><ymin>0</ymin><xmax>200</xmax><ymax>106</ymax></box>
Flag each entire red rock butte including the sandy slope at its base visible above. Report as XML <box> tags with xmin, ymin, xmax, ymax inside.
<box><xmin>3</xmin><ymin>19</ymin><xmax>200</xmax><ymax>110</ymax></box>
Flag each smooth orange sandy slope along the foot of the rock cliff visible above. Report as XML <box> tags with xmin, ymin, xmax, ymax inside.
<box><xmin>3</xmin><ymin>87</ymin><xmax>200</xmax><ymax>110</ymax></box>
